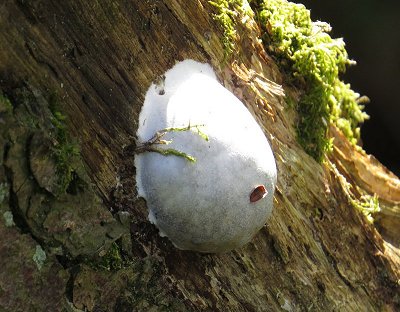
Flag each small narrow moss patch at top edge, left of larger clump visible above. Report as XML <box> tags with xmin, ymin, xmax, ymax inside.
<box><xmin>208</xmin><ymin>0</ymin><xmax>251</xmax><ymax>59</ymax></box>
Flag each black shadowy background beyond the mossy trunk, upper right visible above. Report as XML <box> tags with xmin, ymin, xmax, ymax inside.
<box><xmin>296</xmin><ymin>0</ymin><xmax>400</xmax><ymax>177</ymax></box>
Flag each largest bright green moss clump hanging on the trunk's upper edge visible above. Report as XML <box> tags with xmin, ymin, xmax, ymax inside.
<box><xmin>250</xmin><ymin>0</ymin><xmax>368</xmax><ymax>161</ymax></box>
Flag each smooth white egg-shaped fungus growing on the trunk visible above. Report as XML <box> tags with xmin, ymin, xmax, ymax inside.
<box><xmin>135</xmin><ymin>60</ymin><xmax>276</xmax><ymax>252</ymax></box>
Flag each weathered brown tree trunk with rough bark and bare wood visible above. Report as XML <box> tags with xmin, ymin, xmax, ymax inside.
<box><xmin>0</xmin><ymin>0</ymin><xmax>400</xmax><ymax>311</ymax></box>
